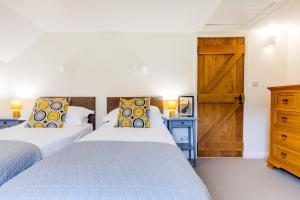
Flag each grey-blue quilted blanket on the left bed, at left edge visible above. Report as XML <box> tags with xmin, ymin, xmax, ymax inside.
<box><xmin>0</xmin><ymin>141</ymin><xmax>42</xmax><ymax>186</ymax></box>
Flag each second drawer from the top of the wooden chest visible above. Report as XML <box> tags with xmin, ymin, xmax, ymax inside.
<box><xmin>274</xmin><ymin>111</ymin><xmax>300</xmax><ymax>129</ymax></box>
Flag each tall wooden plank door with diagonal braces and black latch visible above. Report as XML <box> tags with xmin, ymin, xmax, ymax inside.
<box><xmin>198</xmin><ymin>37</ymin><xmax>245</xmax><ymax>157</ymax></box>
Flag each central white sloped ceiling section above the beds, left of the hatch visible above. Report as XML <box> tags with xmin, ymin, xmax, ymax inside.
<box><xmin>0</xmin><ymin>0</ymin><xmax>219</xmax><ymax>32</ymax></box>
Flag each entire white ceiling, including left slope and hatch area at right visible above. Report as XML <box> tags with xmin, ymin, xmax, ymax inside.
<box><xmin>0</xmin><ymin>0</ymin><xmax>290</xmax><ymax>62</ymax></box>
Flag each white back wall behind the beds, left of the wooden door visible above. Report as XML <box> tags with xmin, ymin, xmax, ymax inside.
<box><xmin>7</xmin><ymin>33</ymin><xmax>196</xmax><ymax>126</ymax></box>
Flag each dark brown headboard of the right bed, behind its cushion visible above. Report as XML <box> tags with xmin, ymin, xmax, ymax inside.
<box><xmin>106</xmin><ymin>97</ymin><xmax>164</xmax><ymax>113</ymax></box>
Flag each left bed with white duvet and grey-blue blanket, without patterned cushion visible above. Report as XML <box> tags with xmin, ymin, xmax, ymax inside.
<box><xmin>0</xmin><ymin>104</ymin><xmax>93</xmax><ymax>186</ymax></box>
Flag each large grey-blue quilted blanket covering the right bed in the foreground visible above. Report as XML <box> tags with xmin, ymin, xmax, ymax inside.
<box><xmin>0</xmin><ymin>141</ymin><xmax>210</xmax><ymax>200</ymax></box>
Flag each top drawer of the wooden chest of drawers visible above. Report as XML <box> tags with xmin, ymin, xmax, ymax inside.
<box><xmin>274</xmin><ymin>92</ymin><xmax>297</xmax><ymax>109</ymax></box>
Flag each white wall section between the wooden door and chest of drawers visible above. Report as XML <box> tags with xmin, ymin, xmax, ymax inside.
<box><xmin>244</xmin><ymin>31</ymin><xmax>287</xmax><ymax>158</ymax></box>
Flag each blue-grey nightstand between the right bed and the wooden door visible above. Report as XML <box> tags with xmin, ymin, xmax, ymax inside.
<box><xmin>165</xmin><ymin>117</ymin><xmax>197</xmax><ymax>167</ymax></box>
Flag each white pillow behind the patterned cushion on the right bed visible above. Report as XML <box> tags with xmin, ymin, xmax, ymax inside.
<box><xmin>102</xmin><ymin>106</ymin><xmax>164</xmax><ymax>127</ymax></box>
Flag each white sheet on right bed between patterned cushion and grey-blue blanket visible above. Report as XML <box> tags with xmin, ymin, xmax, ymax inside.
<box><xmin>79</xmin><ymin>122</ymin><xmax>176</xmax><ymax>145</ymax></box>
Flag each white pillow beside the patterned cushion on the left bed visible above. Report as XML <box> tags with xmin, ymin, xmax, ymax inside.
<box><xmin>65</xmin><ymin>106</ymin><xmax>95</xmax><ymax>126</ymax></box>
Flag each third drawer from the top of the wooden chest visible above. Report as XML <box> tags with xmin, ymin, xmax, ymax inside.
<box><xmin>274</xmin><ymin>128</ymin><xmax>300</xmax><ymax>153</ymax></box>
